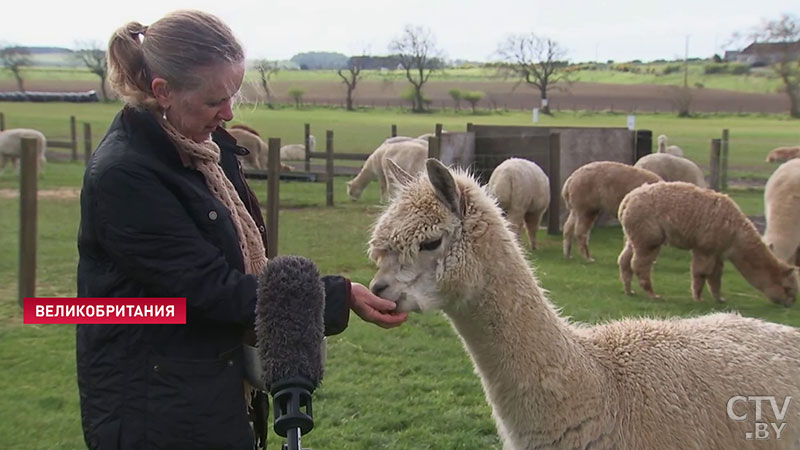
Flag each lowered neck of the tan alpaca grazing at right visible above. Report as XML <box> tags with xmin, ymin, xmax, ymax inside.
<box><xmin>728</xmin><ymin>227</ymin><xmax>784</xmax><ymax>291</ymax></box>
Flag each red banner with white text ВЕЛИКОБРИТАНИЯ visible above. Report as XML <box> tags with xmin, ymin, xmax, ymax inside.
<box><xmin>22</xmin><ymin>297</ymin><xmax>186</xmax><ymax>324</ymax></box>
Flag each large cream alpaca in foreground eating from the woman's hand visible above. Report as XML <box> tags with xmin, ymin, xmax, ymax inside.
<box><xmin>369</xmin><ymin>160</ymin><xmax>800</xmax><ymax>450</ymax></box>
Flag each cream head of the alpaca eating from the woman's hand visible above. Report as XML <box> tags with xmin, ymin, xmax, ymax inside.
<box><xmin>369</xmin><ymin>159</ymin><xmax>515</xmax><ymax>311</ymax></box>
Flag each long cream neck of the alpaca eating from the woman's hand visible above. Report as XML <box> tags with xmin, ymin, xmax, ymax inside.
<box><xmin>445</xmin><ymin>244</ymin><xmax>613</xmax><ymax>445</ymax></box>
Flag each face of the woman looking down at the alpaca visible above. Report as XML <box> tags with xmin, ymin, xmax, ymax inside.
<box><xmin>166</xmin><ymin>62</ymin><xmax>244</xmax><ymax>142</ymax></box>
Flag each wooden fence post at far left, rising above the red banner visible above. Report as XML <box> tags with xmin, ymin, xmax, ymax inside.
<box><xmin>19</xmin><ymin>138</ymin><xmax>39</xmax><ymax>306</ymax></box>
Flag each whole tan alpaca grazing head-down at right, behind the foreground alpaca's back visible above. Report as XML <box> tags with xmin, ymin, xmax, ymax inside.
<box><xmin>617</xmin><ymin>181</ymin><xmax>800</xmax><ymax>306</ymax></box>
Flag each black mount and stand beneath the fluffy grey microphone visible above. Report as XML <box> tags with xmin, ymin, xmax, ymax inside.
<box><xmin>270</xmin><ymin>377</ymin><xmax>314</xmax><ymax>450</ymax></box>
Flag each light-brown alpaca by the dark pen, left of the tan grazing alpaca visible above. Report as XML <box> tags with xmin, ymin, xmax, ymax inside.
<box><xmin>561</xmin><ymin>161</ymin><xmax>662</xmax><ymax>261</ymax></box>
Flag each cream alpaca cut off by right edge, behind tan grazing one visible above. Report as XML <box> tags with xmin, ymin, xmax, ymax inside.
<box><xmin>764</xmin><ymin>159</ymin><xmax>800</xmax><ymax>265</ymax></box>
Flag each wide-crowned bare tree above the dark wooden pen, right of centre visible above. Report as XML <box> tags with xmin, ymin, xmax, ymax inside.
<box><xmin>497</xmin><ymin>33</ymin><xmax>569</xmax><ymax>114</ymax></box>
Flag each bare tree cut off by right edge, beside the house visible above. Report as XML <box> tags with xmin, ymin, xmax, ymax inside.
<box><xmin>751</xmin><ymin>14</ymin><xmax>800</xmax><ymax>118</ymax></box>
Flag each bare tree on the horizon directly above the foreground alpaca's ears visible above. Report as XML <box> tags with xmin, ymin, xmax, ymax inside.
<box><xmin>389</xmin><ymin>25</ymin><xmax>442</xmax><ymax>112</ymax></box>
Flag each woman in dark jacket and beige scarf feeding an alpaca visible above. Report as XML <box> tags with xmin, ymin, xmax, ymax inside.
<box><xmin>76</xmin><ymin>11</ymin><xmax>406</xmax><ymax>450</ymax></box>
